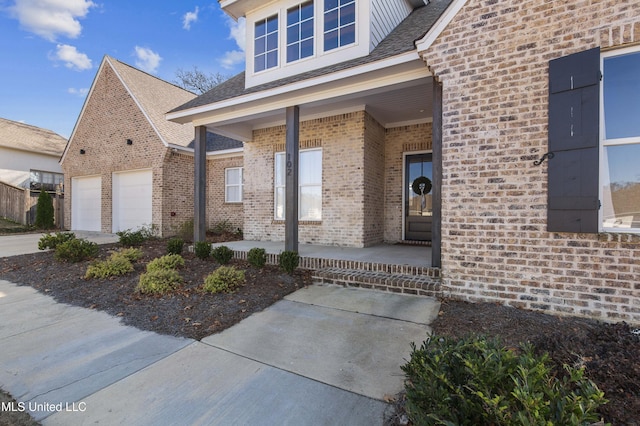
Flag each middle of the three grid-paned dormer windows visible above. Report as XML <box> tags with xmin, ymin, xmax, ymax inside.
<box><xmin>287</xmin><ymin>1</ymin><xmax>314</xmax><ymax>62</ymax></box>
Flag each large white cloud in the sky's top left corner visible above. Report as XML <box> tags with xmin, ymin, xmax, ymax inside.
<box><xmin>10</xmin><ymin>0</ymin><xmax>95</xmax><ymax>41</ymax></box>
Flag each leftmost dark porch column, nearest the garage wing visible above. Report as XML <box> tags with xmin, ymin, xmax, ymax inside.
<box><xmin>193</xmin><ymin>126</ymin><xmax>207</xmax><ymax>242</ymax></box>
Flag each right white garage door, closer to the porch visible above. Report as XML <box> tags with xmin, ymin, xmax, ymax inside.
<box><xmin>113</xmin><ymin>170</ymin><xmax>152</xmax><ymax>232</ymax></box>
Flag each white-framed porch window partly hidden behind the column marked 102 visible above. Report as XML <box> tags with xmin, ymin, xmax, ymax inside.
<box><xmin>274</xmin><ymin>148</ymin><xmax>322</xmax><ymax>221</ymax></box>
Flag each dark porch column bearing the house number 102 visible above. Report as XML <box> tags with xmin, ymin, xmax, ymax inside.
<box><xmin>284</xmin><ymin>105</ymin><xmax>300</xmax><ymax>252</ymax></box>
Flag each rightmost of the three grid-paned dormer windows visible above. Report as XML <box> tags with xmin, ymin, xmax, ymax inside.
<box><xmin>324</xmin><ymin>0</ymin><xmax>356</xmax><ymax>52</ymax></box>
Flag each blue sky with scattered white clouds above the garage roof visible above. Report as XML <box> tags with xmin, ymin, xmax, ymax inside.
<box><xmin>0</xmin><ymin>0</ymin><xmax>244</xmax><ymax>138</ymax></box>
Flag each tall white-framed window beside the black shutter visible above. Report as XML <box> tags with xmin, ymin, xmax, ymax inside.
<box><xmin>600</xmin><ymin>46</ymin><xmax>640</xmax><ymax>233</ymax></box>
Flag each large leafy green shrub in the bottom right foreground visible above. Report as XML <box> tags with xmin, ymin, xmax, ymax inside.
<box><xmin>402</xmin><ymin>337</ymin><xmax>606</xmax><ymax>425</ymax></box>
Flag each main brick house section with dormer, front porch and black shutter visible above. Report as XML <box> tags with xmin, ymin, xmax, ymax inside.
<box><xmin>168</xmin><ymin>0</ymin><xmax>640</xmax><ymax>323</ymax></box>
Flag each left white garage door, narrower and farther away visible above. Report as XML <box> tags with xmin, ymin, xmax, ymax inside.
<box><xmin>71</xmin><ymin>176</ymin><xmax>102</xmax><ymax>232</ymax></box>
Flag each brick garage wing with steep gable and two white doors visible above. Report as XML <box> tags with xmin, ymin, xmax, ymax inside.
<box><xmin>61</xmin><ymin>56</ymin><xmax>243</xmax><ymax>236</ymax></box>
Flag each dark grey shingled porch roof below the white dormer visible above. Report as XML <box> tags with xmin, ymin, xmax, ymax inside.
<box><xmin>170</xmin><ymin>0</ymin><xmax>453</xmax><ymax>112</ymax></box>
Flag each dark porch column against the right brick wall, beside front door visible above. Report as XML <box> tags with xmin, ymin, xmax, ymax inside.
<box><xmin>431</xmin><ymin>76</ymin><xmax>442</xmax><ymax>268</ymax></box>
